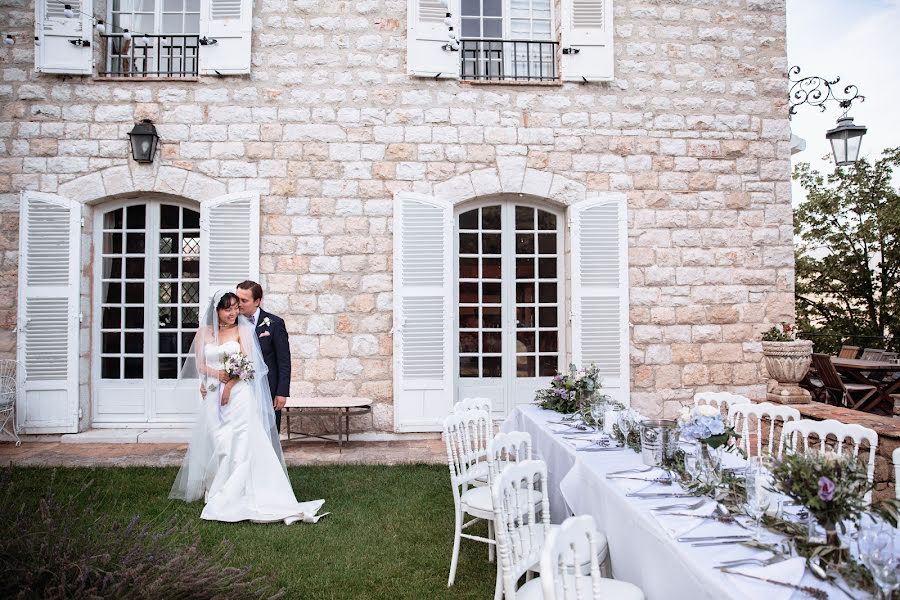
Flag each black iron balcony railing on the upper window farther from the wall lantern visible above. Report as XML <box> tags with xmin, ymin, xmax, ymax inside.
<box><xmin>459</xmin><ymin>39</ymin><xmax>559</xmax><ymax>82</ymax></box>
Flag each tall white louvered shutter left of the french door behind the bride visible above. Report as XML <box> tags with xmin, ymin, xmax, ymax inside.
<box><xmin>16</xmin><ymin>192</ymin><xmax>81</xmax><ymax>433</ymax></box>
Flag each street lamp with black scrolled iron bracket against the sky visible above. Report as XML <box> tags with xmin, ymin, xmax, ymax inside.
<box><xmin>789</xmin><ymin>66</ymin><xmax>867</xmax><ymax>167</ymax></box>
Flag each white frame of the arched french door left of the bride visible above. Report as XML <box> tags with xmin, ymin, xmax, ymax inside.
<box><xmin>91</xmin><ymin>196</ymin><xmax>204</xmax><ymax>429</ymax></box>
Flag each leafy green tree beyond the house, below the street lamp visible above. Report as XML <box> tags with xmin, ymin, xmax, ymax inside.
<box><xmin>794</xmin><ymin>147</ymin><xmax>900</xmax><ymax>351</ymax></box>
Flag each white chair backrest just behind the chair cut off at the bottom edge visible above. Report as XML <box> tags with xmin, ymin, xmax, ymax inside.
<box><xmin>491</xmin><ymin>460</ymin><xmax>550</xmax><ymax>600</ymax></box>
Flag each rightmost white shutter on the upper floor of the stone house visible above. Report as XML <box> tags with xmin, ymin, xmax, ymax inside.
<box><xmin>560</xmin><ymin>0</ymin><xmax>615</xmax><ymax>81</ymax></box>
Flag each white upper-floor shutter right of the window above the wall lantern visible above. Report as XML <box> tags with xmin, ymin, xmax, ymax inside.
<box><xmin>199</xmin><ymin>0</ymin><xmax>253</xmax><ymax>75</ymax></box>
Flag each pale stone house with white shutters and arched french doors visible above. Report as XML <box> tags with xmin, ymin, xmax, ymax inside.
<box><xmin>0</xmin><ymin>0</ymin><xmax>794</xmax><ymax>433</ymax></box>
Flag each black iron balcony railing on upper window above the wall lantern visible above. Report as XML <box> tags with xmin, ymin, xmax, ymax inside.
<box><xmin>99</xmin><ymin>33</ymin><xmax>200</xmax><ymax>79</ymax></box>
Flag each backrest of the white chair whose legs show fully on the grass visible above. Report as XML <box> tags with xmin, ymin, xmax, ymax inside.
<box><xmin>444</xmin><ymin>410</ymin><xmax>491</xmax><ymax>492</ymax></box>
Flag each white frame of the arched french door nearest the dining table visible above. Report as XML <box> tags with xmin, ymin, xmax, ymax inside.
<box><xmin>451</xmin><ymin>195</ymin><xmax>571</xmax><ymax>416</ymax></box>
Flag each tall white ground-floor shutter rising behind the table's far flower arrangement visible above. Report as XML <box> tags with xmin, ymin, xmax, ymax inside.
<box><xmin>571</xmin><ymin>195</ymin><xmax>630</xmax><ymax>405</ymax></box>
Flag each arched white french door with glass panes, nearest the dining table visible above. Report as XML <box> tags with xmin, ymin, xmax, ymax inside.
<box><xmin>455</xmin><ymin>201</ymin><xmax>565</xmax><ymax>414</ymax></box>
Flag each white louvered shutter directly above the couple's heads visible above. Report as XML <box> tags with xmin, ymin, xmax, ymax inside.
<box><xmin>200</xmin><ymin>192</ymin><xmax>259</xmax><ymax>306</ymax></box>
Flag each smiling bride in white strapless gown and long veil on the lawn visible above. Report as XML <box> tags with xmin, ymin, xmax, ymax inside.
<box><xmin>169</xmin><ymin>290</ymin><xmax>327</xmax><ymax>525</ymax></box>
